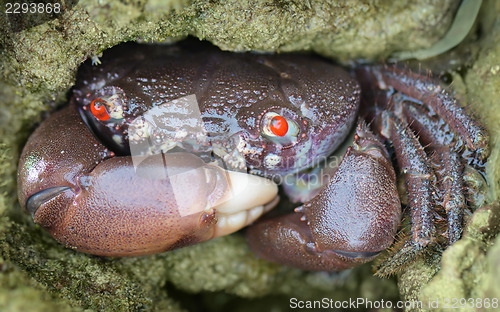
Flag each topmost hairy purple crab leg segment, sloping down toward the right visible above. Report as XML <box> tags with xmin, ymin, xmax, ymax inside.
<box><xmin>365</xmin><ymin>67</ymin><xmax>490</xmax><ymax>160</ymax></box>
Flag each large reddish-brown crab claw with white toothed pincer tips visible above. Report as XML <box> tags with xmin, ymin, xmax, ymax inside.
<box><xmin>18</xmin><ymin>106</ymin><xmax>277</xmax><ymax>256</ymax></box>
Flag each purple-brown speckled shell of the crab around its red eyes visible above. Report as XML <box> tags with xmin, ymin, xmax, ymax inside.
<box><xmin>74</xmin><ymin>45</ymin><xmax>359</xmax><ymax>176</ymax></box>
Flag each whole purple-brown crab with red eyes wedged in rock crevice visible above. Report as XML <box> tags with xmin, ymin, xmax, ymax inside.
<box><xmin>18</xmin><ymin>44</ymin><xmax>488</xmax><ymax>271</ymax></box>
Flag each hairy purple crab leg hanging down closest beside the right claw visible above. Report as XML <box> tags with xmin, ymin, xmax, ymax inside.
<box><xmin>398</xmin><ymin>103</ymin><xmax>467</xmax><ymax>245</ymax></box>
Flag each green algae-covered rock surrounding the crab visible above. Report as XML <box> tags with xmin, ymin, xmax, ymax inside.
<box><xmin>0</xmin><ymin>0</ymin><xmax>499</xmax><ymax>311</ymax></box>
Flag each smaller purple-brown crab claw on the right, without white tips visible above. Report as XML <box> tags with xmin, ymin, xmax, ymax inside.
<box><xmin>246</xmin><ymin>124</ymin><xmax>401</xmax><ymax>271</ymax></box>
